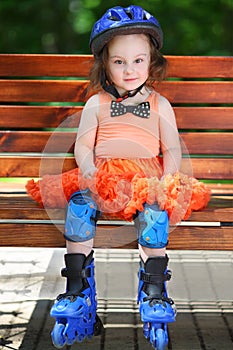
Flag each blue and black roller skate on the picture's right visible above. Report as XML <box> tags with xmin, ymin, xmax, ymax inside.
<box><xmin>138</xmin><ymin>256</ymin><xmax>176</xmax><ymax>350</ymax></box>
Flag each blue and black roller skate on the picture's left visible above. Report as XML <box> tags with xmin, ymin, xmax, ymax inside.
<box><xmin>50</xmin><ymin>251</ymin><xmax>103</xmax><ymax>349</ymax></box>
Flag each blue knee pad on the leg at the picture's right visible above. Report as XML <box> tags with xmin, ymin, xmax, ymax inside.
<box><xmin>134</xmin><ymin>204</ymin><xmax>169</xmax><ymax>248</ymax></box>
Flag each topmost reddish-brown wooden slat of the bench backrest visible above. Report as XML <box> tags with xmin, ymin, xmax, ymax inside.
<box><xmin>0</xmin><ymin>54</ymin><xmax>233</xmax><ymax>78</ymax></box>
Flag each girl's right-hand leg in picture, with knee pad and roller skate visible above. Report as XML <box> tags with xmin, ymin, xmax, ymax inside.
<box><xmin>134</xmin><ymin>203</ymin><xmax>176</xmax><ymax>349</ymax></box>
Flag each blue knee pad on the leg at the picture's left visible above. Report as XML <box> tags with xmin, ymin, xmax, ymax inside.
<box><xmin>64</xmin><ymin>190</ymin><xmax>98</xmax><ymax>242</ymax></box>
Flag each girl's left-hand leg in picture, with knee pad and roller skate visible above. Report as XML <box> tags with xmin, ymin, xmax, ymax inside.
<box><xmin>50</xmin><ymin>191</ymin><xmax>102</xmax><ymax>348</ymax></box>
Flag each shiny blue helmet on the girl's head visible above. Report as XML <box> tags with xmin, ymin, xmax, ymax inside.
<box><xmin>90</xmin><ymin>5</ymin><xmax>163</xmax><ymax>56</ymax></box>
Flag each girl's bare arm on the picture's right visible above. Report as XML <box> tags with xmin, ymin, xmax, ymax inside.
<box><xmin>159</xmin><ymin>96</ymin><xmax>182</xmax><ymax>175</ymax></box>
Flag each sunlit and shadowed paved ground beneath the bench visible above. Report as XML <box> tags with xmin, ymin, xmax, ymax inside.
<box><xmin>0</xmin><ymin>248</ymin><xmax>233</xmax><ymax>350</ymax></box>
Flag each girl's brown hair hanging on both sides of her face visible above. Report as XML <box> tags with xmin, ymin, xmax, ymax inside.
<box><xmin>89</xmin><ymin>34</ymin><xmax>167</xmax><ymax>93</ymax></box>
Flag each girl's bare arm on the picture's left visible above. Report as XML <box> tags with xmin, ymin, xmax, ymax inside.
<box><xmin>74</xmin><ymin>95</ymin><xmax>99</xmax><ymax>178</ymax></box>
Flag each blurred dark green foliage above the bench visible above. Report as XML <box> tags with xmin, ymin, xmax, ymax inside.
<box><xmin>0</xmin><ymin>0</ymin><xmax>233</xmax><ymax>55</ymax></box>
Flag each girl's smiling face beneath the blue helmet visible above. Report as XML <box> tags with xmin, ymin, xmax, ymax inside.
<box><xmin>107</xmin><ymin>34</ymin><xmax>150</xmax><ymax>94</ymax></box>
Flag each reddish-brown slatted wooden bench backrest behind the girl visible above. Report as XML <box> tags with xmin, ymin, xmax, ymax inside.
<box><xmin>0</xmin><ymin>54</ymin><xmax>233</xmax><ymax>180</ymax></box>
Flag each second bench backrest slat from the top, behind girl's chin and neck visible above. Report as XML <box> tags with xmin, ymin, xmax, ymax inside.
<box><xmin>0</xmin><ymin>79</ymin><xmax>233</xmax><ymax>103</ymax></box>
